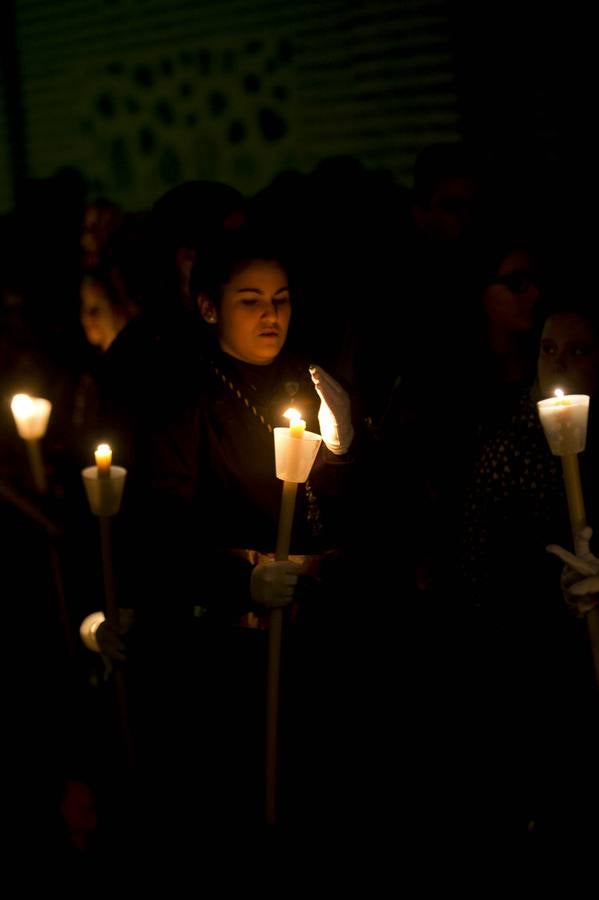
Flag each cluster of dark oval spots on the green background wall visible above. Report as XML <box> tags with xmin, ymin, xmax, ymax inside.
<box><xmin>80</xmin><ymin>39</ymin><xmax>297</xmax><ymax>200</ymax></box>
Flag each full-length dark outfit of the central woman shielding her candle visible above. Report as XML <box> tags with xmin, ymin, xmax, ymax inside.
<box><xmin>110</xmin><ymin>342</ymin><xmax>364</xmax><ymax>829</ymax></box>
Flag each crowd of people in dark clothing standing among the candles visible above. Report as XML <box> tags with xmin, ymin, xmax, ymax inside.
<box><xmin>0</xmin><ymin>144</ymin><xmax>599</xmax><ymax>860</ymax></box>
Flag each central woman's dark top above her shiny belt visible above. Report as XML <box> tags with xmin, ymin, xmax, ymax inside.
<box><xmin>123</xmin><ymin>342</ymin><xmax>352</xmax><ymax>617</ymax></box>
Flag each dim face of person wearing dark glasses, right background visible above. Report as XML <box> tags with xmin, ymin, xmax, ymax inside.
<box><xmin>482</xmin><ymin>250</ymin><xmax>540</xmax><ymax>333</ymax></box>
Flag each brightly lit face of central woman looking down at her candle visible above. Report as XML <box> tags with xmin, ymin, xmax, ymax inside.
<box><xmin>200</xmin><ymin>259</ymin><xmax>291</xmax><ymax>366</ymax></box>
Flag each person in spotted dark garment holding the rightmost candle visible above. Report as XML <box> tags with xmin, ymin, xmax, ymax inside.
<box><xmin>462</xmin><ymin>301</ymin><xmax>599</xmax><ymax>834</ymax></box>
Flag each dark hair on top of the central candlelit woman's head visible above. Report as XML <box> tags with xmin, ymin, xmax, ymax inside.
<box><xmin>189</xmin><ymin>227</ymin><xmax>288</xmax><ymax>306</ymax></box>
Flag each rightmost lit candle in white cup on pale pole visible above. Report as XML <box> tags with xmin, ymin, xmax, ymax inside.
<box><xmin>537</xmin><ymin>389</ymin><xmax>599</xmax><ymax>686</ymax></box>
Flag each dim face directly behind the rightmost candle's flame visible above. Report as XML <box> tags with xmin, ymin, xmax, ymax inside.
<box><xmin>538</xmin><ymin>312</ymin><xmax>599</xmax><ymax>397</ymax></box>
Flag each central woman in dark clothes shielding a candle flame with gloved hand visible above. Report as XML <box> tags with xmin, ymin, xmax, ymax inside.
<box><xmin>105</xmin><ymin>223</ymin><xmax>354</xmax><ymax>820</ymax></box>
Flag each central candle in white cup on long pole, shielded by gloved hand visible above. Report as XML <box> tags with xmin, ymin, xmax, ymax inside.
<box><xmin>265</xmin><ymin>418</ymin><xmax>322</xmax><ymax>825</ymax></box>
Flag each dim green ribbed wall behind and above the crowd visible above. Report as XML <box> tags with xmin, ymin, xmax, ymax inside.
<box><xmin>0</xmin><ymin>0</ymin><xmax>458</xmax><ymax>209</ymax></box>
